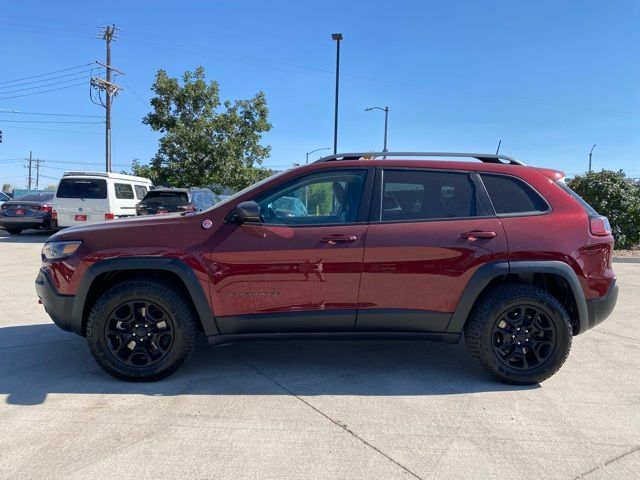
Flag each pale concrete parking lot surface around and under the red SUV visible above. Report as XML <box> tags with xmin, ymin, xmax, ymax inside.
<box><xmin>0</xmin><ymin>230</ymin><xmax>640</xmax><ymax>479</ymax></box>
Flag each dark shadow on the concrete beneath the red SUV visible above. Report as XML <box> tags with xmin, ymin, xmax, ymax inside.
<box><xmin>0</xmin><ymin>324</ymin><xmax>539</xmax><ymax>405</ymax></box>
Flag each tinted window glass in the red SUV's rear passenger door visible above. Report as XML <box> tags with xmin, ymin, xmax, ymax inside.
<box><xmin>380</xmin><ymin>169</ymin><xmax>478</xmax><ymax>222</ymax></box>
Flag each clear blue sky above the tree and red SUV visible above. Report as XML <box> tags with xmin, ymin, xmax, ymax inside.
<box><xmin>0</xmin><ymin>0</ymin><xmax>640</xmax><ymax>187</ymax></box>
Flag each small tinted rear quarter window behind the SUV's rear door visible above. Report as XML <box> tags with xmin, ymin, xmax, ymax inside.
<box><xmin>480</xmin><ymin>173</ymin><xmax>549</xmax><ymax>215</ymax></box>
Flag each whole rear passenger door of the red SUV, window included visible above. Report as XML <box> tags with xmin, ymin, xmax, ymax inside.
<box><xmin>356</xmin><ymin>168</ymin><xmax>507</xmax><ymax>332</ymax></box>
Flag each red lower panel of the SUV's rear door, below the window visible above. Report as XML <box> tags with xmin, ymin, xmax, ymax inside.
<box><xmin>357</xmin><ymin>218</ymin><xmax>506</xmax><ymax>331</ymax></box>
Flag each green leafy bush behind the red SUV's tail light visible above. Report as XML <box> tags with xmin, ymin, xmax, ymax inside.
<box><xmin>568</xmin><ymin>170</ymin><xmax>640</xmax><ymax>248</ymax></box>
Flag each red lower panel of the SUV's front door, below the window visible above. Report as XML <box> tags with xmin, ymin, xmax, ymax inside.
<box><xmin>209</xmin><ymin>224</ymin><xmax>366</xmax><ymax>334</ymax></box>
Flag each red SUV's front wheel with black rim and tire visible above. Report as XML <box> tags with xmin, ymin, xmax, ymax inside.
<box><xmin>87</xmin><ymin>278</ymin><xmax>198</xmax><ymax>381</ymax></box>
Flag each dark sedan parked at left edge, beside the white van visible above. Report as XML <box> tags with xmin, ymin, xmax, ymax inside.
<box><xmin>0</xmin><ymin>192</ymin><xmax>53</xmax><ymax>235</ymax></box>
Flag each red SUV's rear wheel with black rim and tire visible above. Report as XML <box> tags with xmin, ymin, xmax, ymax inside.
<box><xmin>464</xmin><ymin>283</ymin><xmax>572</xmax><ymax>385</ymax></box>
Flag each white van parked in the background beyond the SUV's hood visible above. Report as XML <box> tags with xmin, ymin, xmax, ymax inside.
<box><xmin>52</xmin><ymin>172</ymin><xmax>153</xmax><ymax>228</ymax></box>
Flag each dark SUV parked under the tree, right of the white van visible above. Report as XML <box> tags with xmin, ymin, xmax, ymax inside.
<box><xmin>136</xmin><ymin>187</ymin><xmax>218</xmax><ymax>215</ymax></box>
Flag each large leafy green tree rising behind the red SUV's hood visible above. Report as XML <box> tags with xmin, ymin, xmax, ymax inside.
<box><xmin>132</xmin><ymin>67</ymin><xmax>271</xmax><ymax>190</ymax></box>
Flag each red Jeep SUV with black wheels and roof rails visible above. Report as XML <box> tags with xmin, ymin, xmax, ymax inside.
<box><xmin>36</xmin><ymin>152</ymin><xmax>618</xmax><ymax>384</ymax></box>
